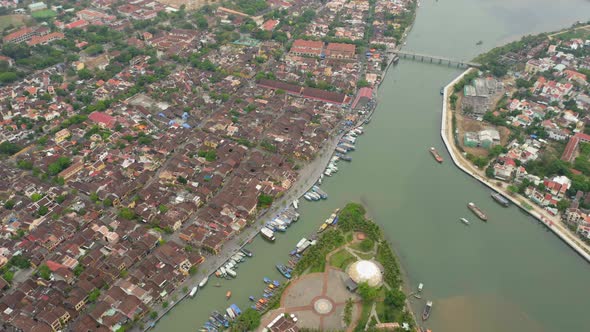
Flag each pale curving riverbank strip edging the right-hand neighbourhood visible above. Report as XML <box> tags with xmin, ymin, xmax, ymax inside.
<box><xmin>440</xmin><ymin>68</ymin><xmax>590</xmax><ymax>262</ymax></box>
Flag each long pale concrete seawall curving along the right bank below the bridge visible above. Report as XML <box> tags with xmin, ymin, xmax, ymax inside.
<box><xmin>440</xmin><ymin>69</ymin><xmax>590</xmax><ymax>262</ymax></box>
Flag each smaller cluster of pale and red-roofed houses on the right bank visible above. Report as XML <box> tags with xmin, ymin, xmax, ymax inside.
<box><xmin>455</xmin><ymin>25</ymin><xmax>590</xmax><ymax>240</ymax></box>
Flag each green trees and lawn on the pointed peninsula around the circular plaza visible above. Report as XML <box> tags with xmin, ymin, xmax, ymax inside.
<box><xmin>263</xmin><ymin>203</ymin><xmax>419</xmax><ymax>331</ymax></box>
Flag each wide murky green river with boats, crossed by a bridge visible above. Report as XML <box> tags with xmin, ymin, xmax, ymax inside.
<box><xmin>156</xmin><ymin>0</ymin><xmax>590</xmax><ymax>332</ymax></box>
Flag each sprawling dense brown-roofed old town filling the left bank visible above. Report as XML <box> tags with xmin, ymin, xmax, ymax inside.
<box><xmin>0</xmin><ymin>0</ymin><xmax>413</xmax><ymax>331</ymax></box>
